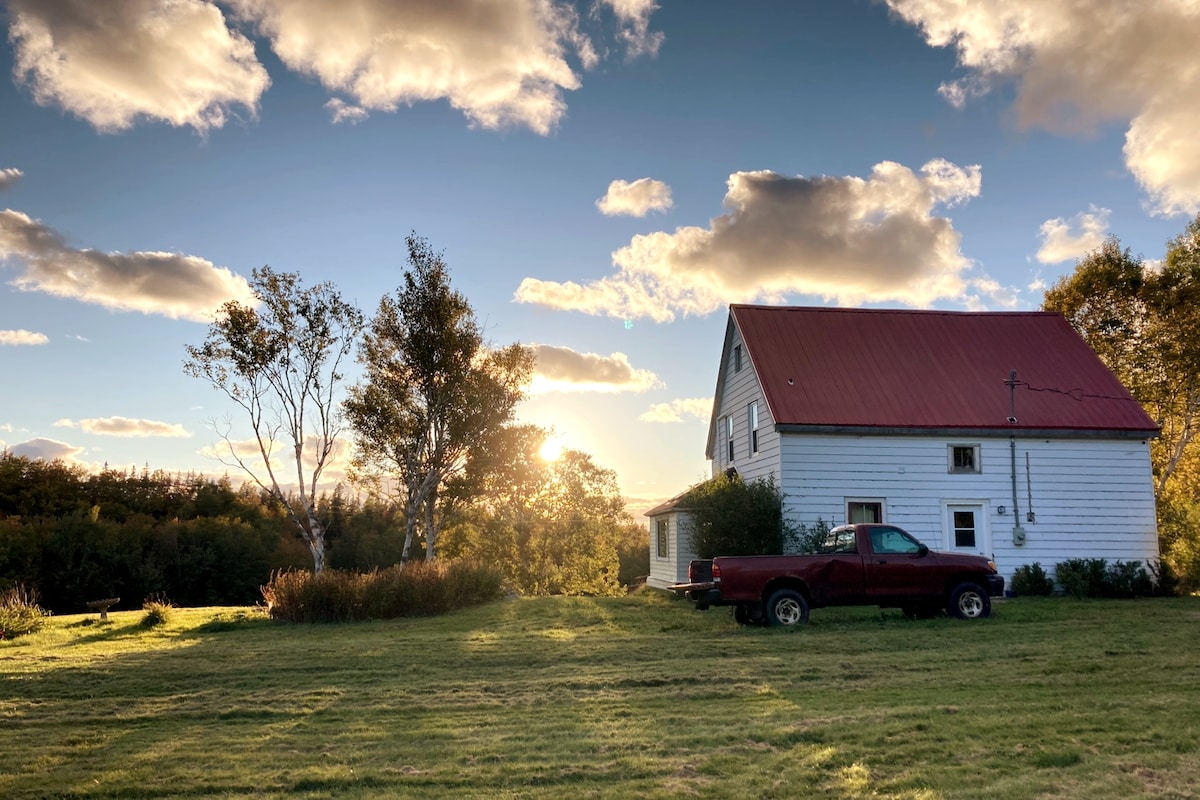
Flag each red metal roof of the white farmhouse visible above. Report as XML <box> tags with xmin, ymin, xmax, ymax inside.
<box><xmin>730</xmin><ymin>305</ymin><xmax>1158</xmax><ymax>434</ymax></box>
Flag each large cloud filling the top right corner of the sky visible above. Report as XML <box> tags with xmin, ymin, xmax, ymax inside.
<box><xmin>887</xmin><ymin>0</ymin><xmax>1200</xmax><ymax>215</ymax></box>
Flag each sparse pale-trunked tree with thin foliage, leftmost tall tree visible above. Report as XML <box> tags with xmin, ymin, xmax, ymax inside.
<box><xmin>185</xmin><ymin>266</ymin><xmax>362</xmax><ymax>573</ymax></box>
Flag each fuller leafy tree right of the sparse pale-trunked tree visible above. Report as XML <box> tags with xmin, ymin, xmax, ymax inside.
<box><xmin>344</xmin><ymin>234</ymin><xmax>533</xmax><ymax>561</ymax></box>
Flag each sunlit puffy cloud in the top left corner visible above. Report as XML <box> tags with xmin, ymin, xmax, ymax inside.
<box><xmin>8</xmin><ymin>0</ymin><xmax>270</xmax><ymax>132</ymax></box>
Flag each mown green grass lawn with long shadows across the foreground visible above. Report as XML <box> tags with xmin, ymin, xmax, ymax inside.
<box><xmin>0</xmin><ymin>590</ymin><xmax>1200</xmax><ymax>800</ymax></box>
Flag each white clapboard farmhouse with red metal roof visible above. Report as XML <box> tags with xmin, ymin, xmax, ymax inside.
<box><xmin>647</xmin><ymin>305</ymin><xmax>1158</xmax><ymax>588</ymax></box>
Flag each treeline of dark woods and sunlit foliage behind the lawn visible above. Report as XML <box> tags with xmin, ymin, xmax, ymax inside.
<box><xmin>0</xmin><ymin>453</ymin><xmax>649</xmax><ymax>613</ymax></box>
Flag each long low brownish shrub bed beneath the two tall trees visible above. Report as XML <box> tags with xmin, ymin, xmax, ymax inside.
<box><xmin>263</xmin><ymin>561</ymin><xmax>504</xmax><ymax>622</ymax></box>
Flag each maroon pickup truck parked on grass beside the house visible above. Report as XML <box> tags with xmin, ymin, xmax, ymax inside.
<box><xmin>671</xmin><ymin>523</ymin><xmax>1004</xmax><ymax>625</ymax></box>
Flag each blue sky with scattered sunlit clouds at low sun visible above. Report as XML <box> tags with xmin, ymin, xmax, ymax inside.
<box><xmin>0</xmin><ymin>0</ymin><xmax>1200</xmax><ymax>511</ymax></box>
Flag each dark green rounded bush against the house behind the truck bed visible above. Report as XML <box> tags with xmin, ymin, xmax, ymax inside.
<box><xmin>679</xmin><ymin>473</ymin><xmax>787</xmax><ymax>559</ymax></box>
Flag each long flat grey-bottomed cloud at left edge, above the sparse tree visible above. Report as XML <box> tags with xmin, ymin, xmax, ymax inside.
<box><xmin>0</xmin><ymin>209</ymin><xmax>254</xmax><ymax>321</ymax></box>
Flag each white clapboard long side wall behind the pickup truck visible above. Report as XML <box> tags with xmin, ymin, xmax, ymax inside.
<box><xmin>779</xmin><ymin>433</ymin><xmax>1158</xmax><ymax>577</ymax></box>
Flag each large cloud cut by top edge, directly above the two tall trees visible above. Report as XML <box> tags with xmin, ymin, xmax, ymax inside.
<box><xmin>228</xmin><ymin>0</ymin><xmax>614</xmax><ymax>133</ymax></box>
